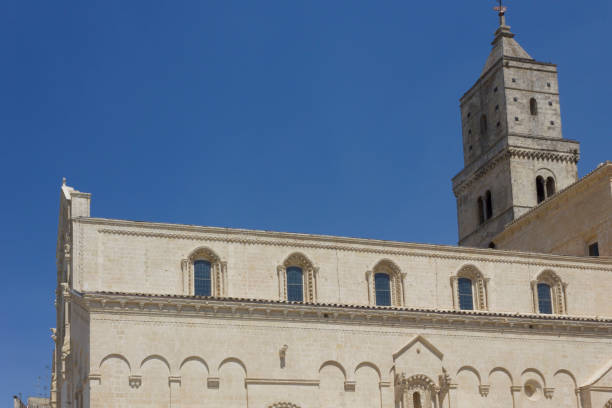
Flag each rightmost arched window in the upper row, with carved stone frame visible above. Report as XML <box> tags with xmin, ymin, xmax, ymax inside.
<box><xmin>531</xmin><ymin>270</ymin><xmax>567</xmax><ymax>314</ymax></box>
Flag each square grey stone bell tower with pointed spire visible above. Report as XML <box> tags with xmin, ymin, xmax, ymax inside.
<box><xmin>453</xmin><ymin>5</ymin><xmax>580</xmax><ymax>248</ymax></box>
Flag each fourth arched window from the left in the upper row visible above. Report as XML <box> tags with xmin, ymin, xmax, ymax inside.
<box><xmin>451</xmin><ymin>265</ymin><xmax>489</xmax><ymax>310</ymax></box>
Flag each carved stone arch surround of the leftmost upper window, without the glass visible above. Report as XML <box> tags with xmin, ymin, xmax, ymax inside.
<box><xmin>181</xmin><ymin>247</ymin><xmax>227</xmax><ymax>296</ymax></box>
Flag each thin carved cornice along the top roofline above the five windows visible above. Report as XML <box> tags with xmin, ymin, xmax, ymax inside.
<box><xmin>87</xmin><ymin>223</ymin><xmax>612</xmax><ymax>272</ymax></box>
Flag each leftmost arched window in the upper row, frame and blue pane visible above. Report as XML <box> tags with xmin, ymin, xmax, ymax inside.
<box><xmin>181</xmin><ymin>247</ymin><xmax>227</xmax><ymax>296</ymax></box>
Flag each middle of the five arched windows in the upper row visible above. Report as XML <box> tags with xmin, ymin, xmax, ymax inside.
<box><xmin>366</xmin><ymin>259</ymin><xmax>405</xmax><ymax>306</ymax></box>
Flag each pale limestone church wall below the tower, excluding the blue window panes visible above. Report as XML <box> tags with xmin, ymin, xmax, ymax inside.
<box><xmin>53</xmin><ymin>186</ymin><xmax>612</xmax><ymax>408</ymax></box>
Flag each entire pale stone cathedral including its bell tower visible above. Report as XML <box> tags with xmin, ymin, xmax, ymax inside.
<box><xmin>51</xmin><ymin>11</ymin><xmax>612</xmax><ymax>408</ymax></box>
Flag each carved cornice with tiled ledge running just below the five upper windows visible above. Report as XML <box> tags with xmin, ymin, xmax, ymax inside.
<box><xmin>73</xmin><ymin>293</ymin><xmax>612</xmax><ymax>337</ymax></box>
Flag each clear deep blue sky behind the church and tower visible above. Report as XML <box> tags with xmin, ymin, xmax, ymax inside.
<box><xmin>0</xmin><ymin>0</ymin><xmax>612</xmax><ymax>406</ymax></box>
